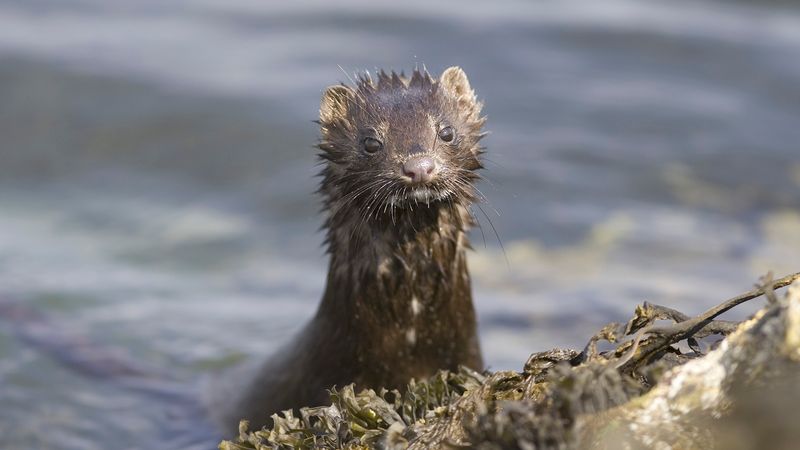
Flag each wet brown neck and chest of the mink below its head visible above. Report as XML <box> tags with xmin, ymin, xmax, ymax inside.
<box><xmin>315</xmin><ymin>204</ymin><xmax>482</xmax><ymax>384</ymax></box>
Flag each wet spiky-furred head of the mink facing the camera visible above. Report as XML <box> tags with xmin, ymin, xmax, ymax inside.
<box><xmin>319</xmin><ymin>67</ymin><xmax>485</xmax><ymax>220</ymax></box>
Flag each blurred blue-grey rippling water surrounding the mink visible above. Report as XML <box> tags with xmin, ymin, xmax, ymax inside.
<box><xmin>0</xmin><ymin>0</ymin><xmax>800</xmax><ymax>450</ymax></box>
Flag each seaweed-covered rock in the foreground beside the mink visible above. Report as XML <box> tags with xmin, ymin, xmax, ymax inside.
<box><xmin>220</xmin><ymin>274</ymin><xmax>800</xmax><ymax>450</ymax></box>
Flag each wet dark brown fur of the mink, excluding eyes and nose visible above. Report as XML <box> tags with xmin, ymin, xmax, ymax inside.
<box><xmin>225</xmin><ymin>67</ymin><xmax>484</xmax><ymax>426</ymax></box>
